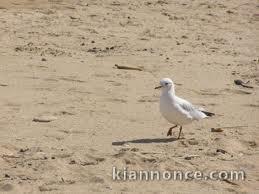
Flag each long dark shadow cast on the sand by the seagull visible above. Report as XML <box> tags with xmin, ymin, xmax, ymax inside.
<box><xmin>112</xmin><ymin>137</ymin><xmax>179</xmax><ymax>146</ymax></box>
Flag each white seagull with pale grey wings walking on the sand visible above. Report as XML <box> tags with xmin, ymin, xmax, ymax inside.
<box><xmin>155</xmin><ymin>78</ymin><xmax>215</xmax><ymax>139</ymax></box>
